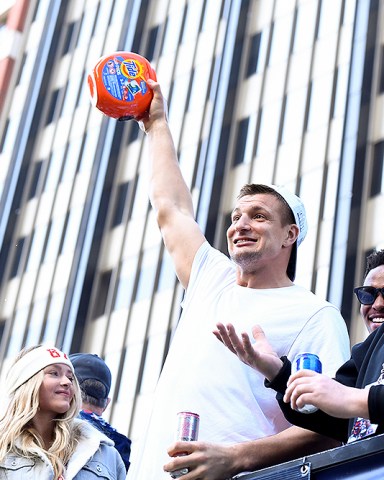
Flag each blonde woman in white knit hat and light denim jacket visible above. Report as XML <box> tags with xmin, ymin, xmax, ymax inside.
<box><xmin>0</xmin><ymin>345</ymin><xmax>126</xmax><ymax>480</ymax></box>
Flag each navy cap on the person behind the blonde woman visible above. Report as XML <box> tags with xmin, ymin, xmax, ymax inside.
<box><xmin>69</xmin><ymin>353</ymin><xmax>112</xmax><ymax>398</ymax></box>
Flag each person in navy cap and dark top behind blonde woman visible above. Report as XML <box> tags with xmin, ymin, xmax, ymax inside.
<box><xmin>69</xmin><ymin>353</ymin><xmax>131</xmax><ymax>471</ymax></box>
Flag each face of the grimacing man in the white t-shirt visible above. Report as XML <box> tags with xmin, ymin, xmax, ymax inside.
<box><xmin>227</xmin><ymin>193</ymin><xmax>297</xmax><ymax>272</ymax></box>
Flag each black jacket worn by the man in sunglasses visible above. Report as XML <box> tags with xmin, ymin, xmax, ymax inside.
<box><xmin>265</xmin><ymin>325</ymin><xmax>384</xmax><ymax>442</ymax></box>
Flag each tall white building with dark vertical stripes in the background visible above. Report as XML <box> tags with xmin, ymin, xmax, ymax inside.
<box><xmin>0</xmin><ymin>0</ymin><xmax>384</xmax><ymax>446</ymax></box>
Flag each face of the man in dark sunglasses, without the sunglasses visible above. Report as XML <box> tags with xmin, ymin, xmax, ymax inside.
<box><xmin>360</xmin><ymin>265</ymin><xmax>384</xmax><ymax>333</ymax></box>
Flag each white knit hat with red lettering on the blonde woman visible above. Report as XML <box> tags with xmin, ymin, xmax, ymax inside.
<box><xmin>5</xmin><ymin>345</ymin><xmax>74</xmax><ymax>395</ymax></box>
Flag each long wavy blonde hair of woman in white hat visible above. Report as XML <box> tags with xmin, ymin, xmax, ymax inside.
<box><xmin>0</xmin><ymin>347</ymin><xmax>81</xmax><ymax>478</ymax></box>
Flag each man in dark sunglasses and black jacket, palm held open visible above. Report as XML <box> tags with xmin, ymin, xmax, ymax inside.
<box><xmin>215</xmin><ymin>250</ymin><xmax>384</xmax><ymax>443</ymax></box>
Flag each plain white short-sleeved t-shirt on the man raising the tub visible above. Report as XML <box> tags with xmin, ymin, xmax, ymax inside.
<box><xmin>128</xmin><ymin>242</ymin><xmax>350</xmax><ymax>480</ymax></box>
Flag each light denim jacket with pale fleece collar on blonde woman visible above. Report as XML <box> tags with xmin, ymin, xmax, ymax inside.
<box><xmin>0</xmin><ymin>420</ymin><xmax>126</xmax><ymax>480</ymax></box>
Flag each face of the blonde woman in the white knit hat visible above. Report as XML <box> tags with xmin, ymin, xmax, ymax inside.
<box><xmin>39</xmin><ymin>363</ymin><xmax>74</xmax><ymax>417</ymax></box>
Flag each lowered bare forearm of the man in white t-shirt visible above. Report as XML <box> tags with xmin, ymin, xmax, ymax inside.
<box><xmin>231</xmin><ymin>427</ymin><xmax>340</xmax><ymax>473</ymax></box>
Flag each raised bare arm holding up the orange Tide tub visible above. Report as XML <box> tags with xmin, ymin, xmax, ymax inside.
<box><xmin>140</xmin><ymin>80</ymin><xmax>205</xmax><ymax>288</ymax></box>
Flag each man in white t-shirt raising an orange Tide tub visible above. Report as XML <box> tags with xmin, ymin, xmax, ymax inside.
<box><xmin>128</xmin><ymin>81</ymin><xmax>349</xmax><ymax>480</ymax></box>
